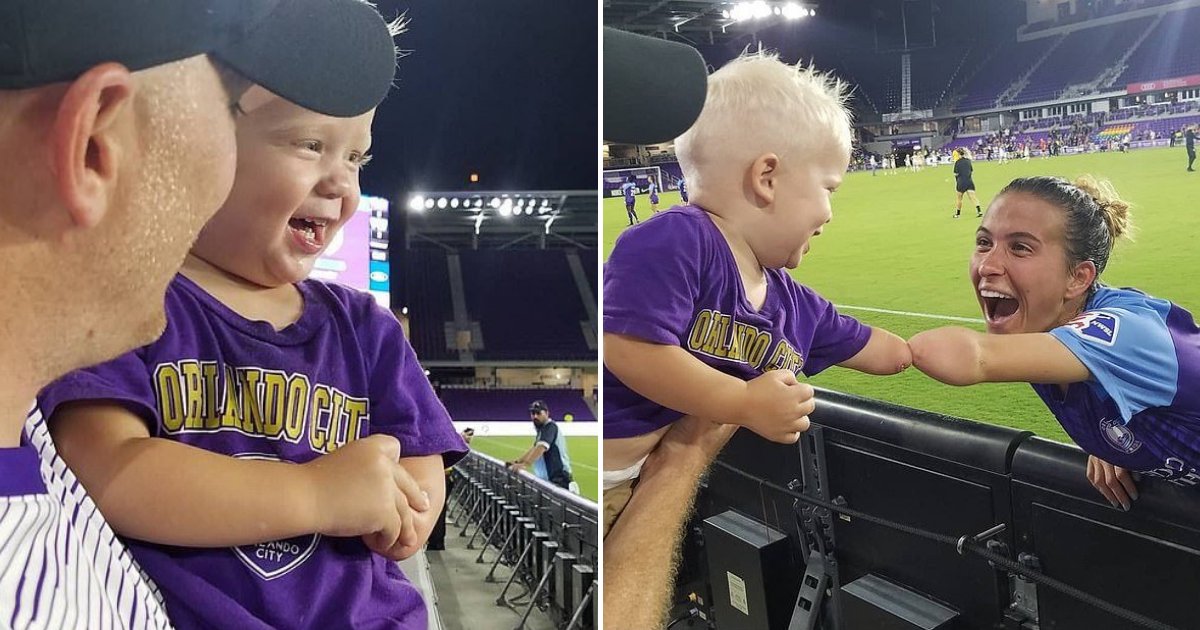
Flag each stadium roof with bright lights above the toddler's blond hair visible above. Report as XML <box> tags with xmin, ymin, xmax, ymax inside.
<box><xmin>604</xmin><ymin>0</ymin><xmax>818</xmax><ymax>44</ymax></box>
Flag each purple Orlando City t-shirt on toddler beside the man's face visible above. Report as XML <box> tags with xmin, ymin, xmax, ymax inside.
<box><xmin>38</xmin><ymin>276</ymin><xmax>466</xmax><ymax>629</ymax></box>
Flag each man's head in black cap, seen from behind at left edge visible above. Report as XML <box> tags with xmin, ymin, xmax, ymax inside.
<box><xmin>0</xmin><ymin>0</ymin><xmax>395</xmax><ymax>379</ymax></box>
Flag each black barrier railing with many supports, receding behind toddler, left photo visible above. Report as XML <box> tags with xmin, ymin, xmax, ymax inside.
<box><xmin>448</xmin><ymin>451</ymin><xmax>599</xmax><ymax>630</ymax></box>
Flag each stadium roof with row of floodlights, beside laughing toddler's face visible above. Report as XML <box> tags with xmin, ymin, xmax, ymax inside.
<box><xmin>400</xmin><ymin>191</ymin><xmax>598</xmax><ymax>251</ymax></box>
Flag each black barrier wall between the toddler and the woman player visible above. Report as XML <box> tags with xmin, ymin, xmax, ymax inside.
<box><xmin>679</xmin><ymin>390</ymin><xmax>1200</xmax><ymax>630</ymax></box>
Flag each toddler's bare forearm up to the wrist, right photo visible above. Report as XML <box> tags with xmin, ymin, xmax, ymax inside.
<box><xmin>604</xmin><ymin>332</ymin><xmax>746</xmax><ymax>421</ymax></box>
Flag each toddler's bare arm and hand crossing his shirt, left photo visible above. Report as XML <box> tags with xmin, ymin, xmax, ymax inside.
<box><xmin>49</xmin><ymin>401</ymin><xmax>437</xmax><ymax>548</ymax></box>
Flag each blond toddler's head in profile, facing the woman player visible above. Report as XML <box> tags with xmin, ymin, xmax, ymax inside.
<box><xmin>676</xmin><ymin>53</ymin><xmax>851</xmax><ymax>268</ymax></box>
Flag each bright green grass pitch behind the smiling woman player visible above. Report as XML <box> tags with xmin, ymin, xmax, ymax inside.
<box><xmin>604</xmin><ymin>148</ymin><xmax>1200</xmax><ymax>442</ymax></box>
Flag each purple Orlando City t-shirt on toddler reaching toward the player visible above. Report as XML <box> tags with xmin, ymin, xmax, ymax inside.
<box><xmin>604</xmin><ymin>205</ymin><xmax>871</xmax><ymax>438</ymax></box>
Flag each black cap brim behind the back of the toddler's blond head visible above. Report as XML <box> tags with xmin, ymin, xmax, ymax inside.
<box><xmin>604</xmin><ymin>26</ymin><xmax>708</xmax><ymax>144</ymax></box>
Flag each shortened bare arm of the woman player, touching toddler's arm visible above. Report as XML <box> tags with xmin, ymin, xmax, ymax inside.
<box><xmin>908</xmin><ymin>326</ymin><xmax>1091</xmax><ymax>385</ymax></box>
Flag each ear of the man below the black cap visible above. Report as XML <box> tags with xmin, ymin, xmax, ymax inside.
<box><xmin>50</xmin><ymin>64</ymin><xmax>133</xmax><ymax>228</ymax></box>
